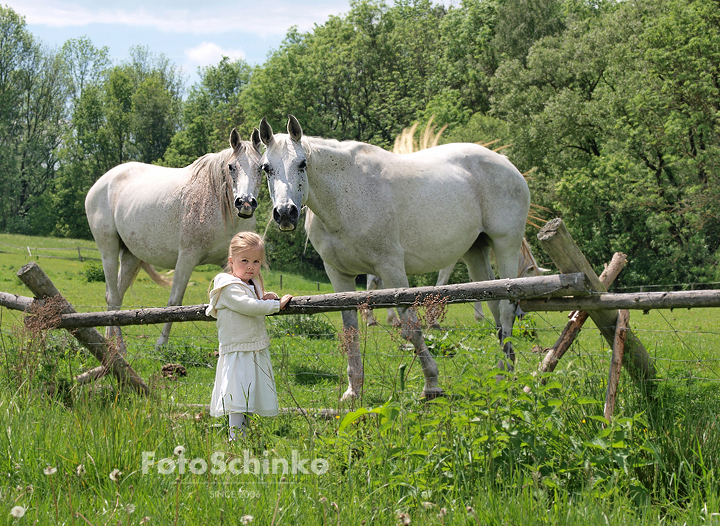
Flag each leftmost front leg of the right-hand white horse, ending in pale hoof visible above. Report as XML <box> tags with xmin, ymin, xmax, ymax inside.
<box><xmin>325</xmin><ymin>263</ymin><xmax>365</xmax><ymax>402</ymax></box>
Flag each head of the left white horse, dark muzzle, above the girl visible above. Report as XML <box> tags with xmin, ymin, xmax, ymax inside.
<box><xmin>228</xmin><ymin>128</ymin><xmax>262</xmax><ymax>219</ymax></box>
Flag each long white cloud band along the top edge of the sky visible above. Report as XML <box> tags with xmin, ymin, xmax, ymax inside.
<box><xmin>6</xmin><ymin>0</ymin><xmax>349</xmax><ymax>35</ymax></box>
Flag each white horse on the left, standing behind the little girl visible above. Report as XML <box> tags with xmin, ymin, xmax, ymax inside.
<box><xmin>85</xmin><ymin>128</ymin><xmax>262</xmax><ymax>346</ymax></box>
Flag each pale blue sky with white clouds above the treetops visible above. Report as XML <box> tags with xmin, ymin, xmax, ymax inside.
<box><xmin>5</xmin><ymin>0</ymin><xmax>350</xmax><ymax>84</ymax></box>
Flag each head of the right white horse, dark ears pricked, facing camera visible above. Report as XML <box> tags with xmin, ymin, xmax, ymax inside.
<box><xmin>260</xmin><ymin>115</ymin><xmax>307</xmax><ymax>232</ymax></box>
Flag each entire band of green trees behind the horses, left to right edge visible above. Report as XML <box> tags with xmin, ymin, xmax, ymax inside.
<box><xmin>0</xmin><ymin>0</ymin><xmax>720</xmax><ymax>285</ymax></box>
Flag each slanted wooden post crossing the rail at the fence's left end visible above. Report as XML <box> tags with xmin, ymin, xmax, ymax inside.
<box><xmin>17</xmin><ymin>261</ymin><xmax>149</xmax><ymax>394</ymax></box>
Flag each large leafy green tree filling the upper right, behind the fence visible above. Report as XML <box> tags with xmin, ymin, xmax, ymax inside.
<box><xmin>493</xmin><ymin>0</ymin><xmax>720</xmax><ymax>284</ymax></box>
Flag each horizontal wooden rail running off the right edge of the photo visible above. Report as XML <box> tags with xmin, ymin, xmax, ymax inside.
<box><xmin>520</xmin><ymin>290</ymin><xmax>720</xmax><ymax>312</ymax></box>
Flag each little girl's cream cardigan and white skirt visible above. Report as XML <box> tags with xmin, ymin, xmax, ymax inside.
<box><xmin>207</xmin><ymin>273</ymin><xmax>280</xmax><ymax>416</ymax></box>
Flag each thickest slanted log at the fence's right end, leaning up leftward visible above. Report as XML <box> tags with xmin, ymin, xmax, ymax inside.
<box><xmin>538</xmin><ymin>218</ymin><xmax>655</xmax><ymax>381</ymax></box>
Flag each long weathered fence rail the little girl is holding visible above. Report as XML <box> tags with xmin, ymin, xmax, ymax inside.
<box><xmin>49</xmin><ymin>273</ymin><xmax>589</xmax><ymax>329</ymax></box>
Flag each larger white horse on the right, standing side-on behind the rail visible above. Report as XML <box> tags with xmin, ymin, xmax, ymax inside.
<box><xmin>260</xmin><ymin>116</ymin><xmax>530</xmax><ymax>399</ymax></box>
